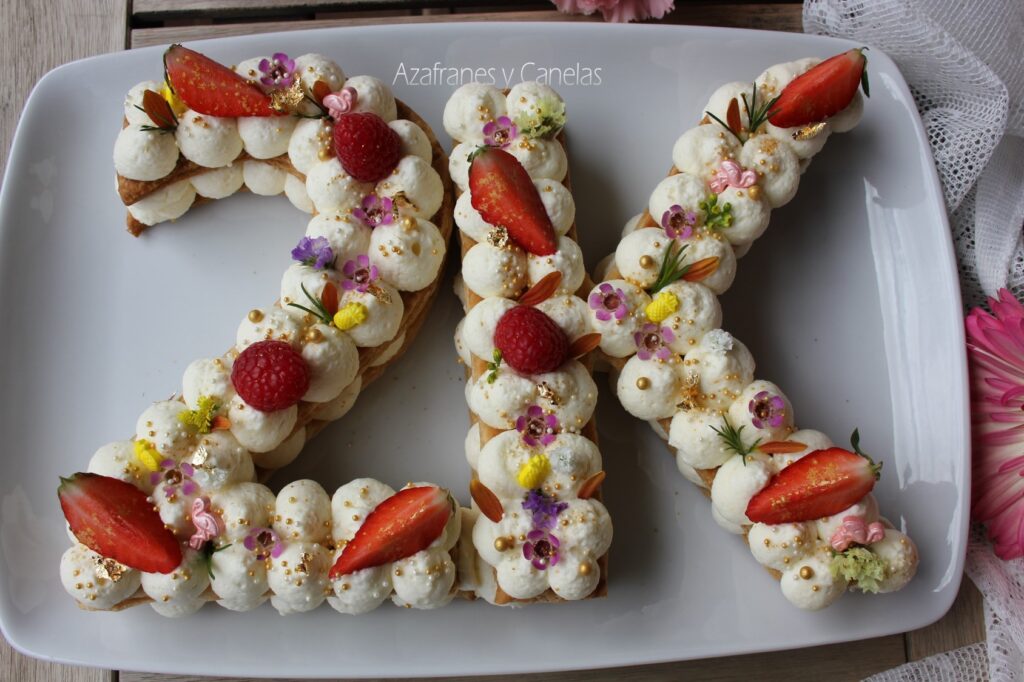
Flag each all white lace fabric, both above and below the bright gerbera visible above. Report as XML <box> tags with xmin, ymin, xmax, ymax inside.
<box><xmin>804</xmin><ymin>0</ymin><xmax>1024</xmax><ymax>682</ymax></box>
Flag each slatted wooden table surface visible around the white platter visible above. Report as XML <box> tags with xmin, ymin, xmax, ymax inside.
<box><xmin>0</xmin><ymin>0</ymin><xmax>985</xmax><ymax>682</ymax></box>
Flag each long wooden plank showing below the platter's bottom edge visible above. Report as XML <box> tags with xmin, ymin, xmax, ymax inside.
<box><xmin>121</xmin><ymin>635</ymin><xmax>906</xmax><ymax>682</ymax></box>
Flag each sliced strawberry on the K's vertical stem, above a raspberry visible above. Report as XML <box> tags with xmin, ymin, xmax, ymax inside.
<box><xmin>469</xmin><ymin>146</ymin><xmax>558</xmax><ymax>256</ymax></box>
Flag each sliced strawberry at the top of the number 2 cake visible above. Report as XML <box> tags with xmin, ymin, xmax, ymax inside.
<box><xmin>164</xmin><ymin>45</ymin><xmax>282</xmax><ymax>117</ymax></box>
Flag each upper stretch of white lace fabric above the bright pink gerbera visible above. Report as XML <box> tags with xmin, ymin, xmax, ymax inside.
<box><xmin>804</xmin><ymin>0</ymin><xmax>1024</xmax><ymax>306</ymax></box>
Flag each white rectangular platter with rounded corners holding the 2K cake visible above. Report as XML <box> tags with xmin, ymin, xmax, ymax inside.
<box><xmin>0</xmin><ymin>19</ymin><xmax>970</xmax><ymax>677</ymax></box>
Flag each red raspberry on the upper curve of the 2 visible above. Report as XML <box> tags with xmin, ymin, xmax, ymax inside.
<box><xmin>334</xmin><ymin>114</ymin><xmax>401</xmax><ymax>182</ymax></box>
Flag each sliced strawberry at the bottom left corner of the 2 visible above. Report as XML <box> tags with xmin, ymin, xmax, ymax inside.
<box><xmin>57</xmin><ymin>473</ymin><xmax>181</xmax><ymax>573</ymax></box>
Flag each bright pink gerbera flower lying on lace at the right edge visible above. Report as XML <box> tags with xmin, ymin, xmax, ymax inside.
<box><xmin>967</xmin><ymin>289</ymin><xmax>1024</xmax><ymax>559</ymax></box>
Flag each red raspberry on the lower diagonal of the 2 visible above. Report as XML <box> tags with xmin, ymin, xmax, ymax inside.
<box><xmin>231</xmin><ymin>341</ymin><xmax>309</xmax><ymax>412</ymax></box>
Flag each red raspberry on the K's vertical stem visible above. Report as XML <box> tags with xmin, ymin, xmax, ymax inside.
<box><xmin>495</xmin><ymin>305</ymin><xmax>569</xmax><ymax>374</ymax></box>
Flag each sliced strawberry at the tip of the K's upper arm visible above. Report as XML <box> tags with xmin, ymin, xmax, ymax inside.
<box><xmin>768</xmin><ymin>48</ymin><xmax>867</xmax><ymax>128</ymax></box>
